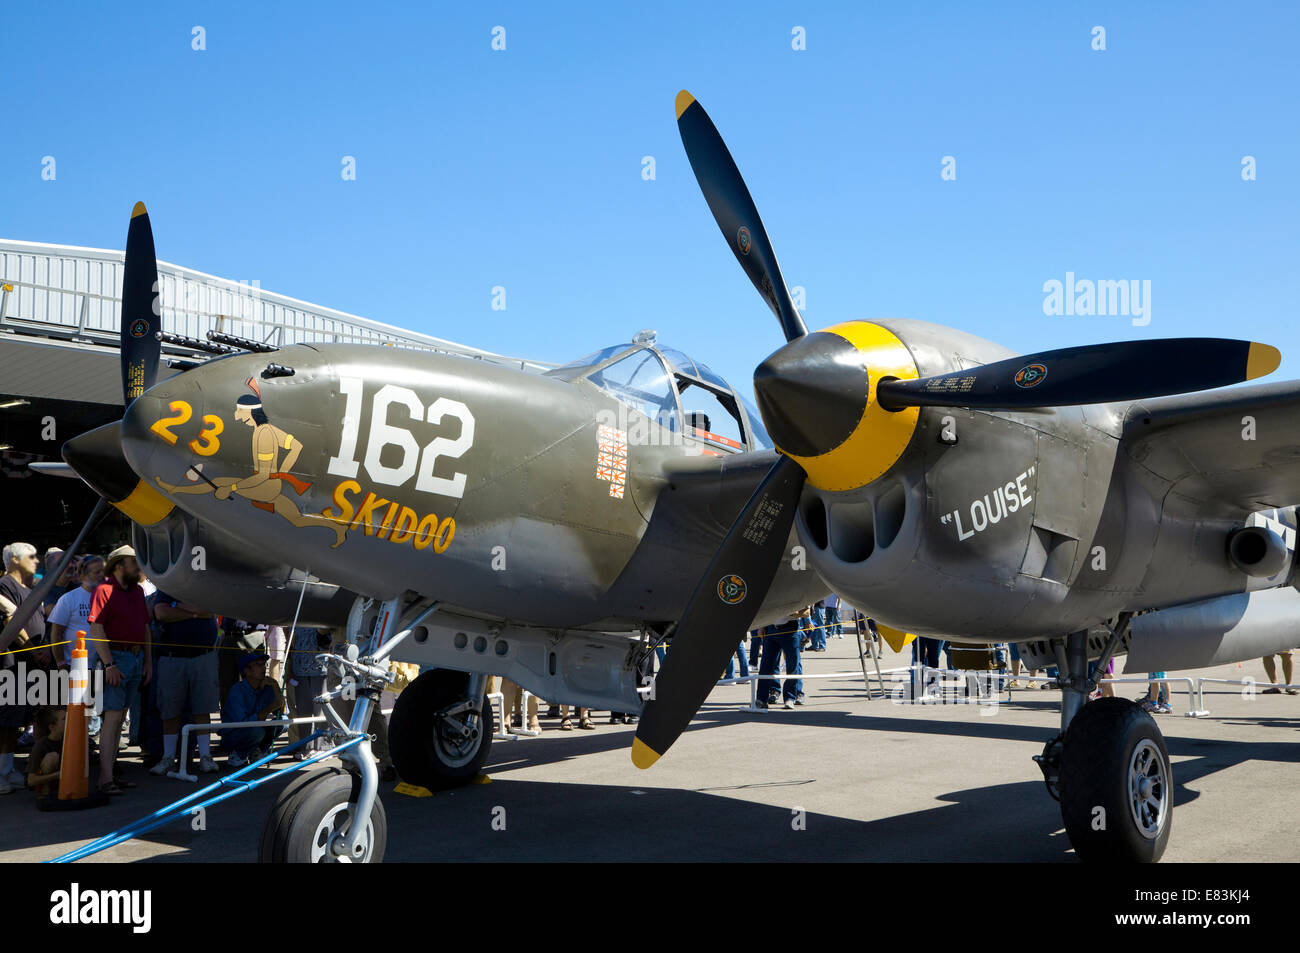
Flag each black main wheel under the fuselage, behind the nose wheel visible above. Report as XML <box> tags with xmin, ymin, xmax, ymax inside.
<box><xmin>389</xmin><ymin>668</ymin><xmax>493</xmax><ymax>790</ymax></box>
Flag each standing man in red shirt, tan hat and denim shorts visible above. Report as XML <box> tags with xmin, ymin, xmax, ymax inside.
<box><xmin>88</xmin><ymin>546</ymin><xmax>153</xmax><ymax>794</ymax></box>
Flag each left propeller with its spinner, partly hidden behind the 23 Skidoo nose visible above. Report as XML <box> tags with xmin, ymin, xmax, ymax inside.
<box><xmin>0</xmin><ymin>202</ymin><xmax>172</xmax><ymax>646</ymax></box>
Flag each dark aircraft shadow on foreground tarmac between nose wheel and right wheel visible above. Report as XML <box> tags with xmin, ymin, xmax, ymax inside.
<box><xmin>377</xmin><ymin>780</ymin><xmax>1070</xmax><ymax>862</ymax></box>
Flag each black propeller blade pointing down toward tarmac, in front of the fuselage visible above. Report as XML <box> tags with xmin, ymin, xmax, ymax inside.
<box><xmin>632</xmin><ymin>456</ymin><xmax>805</xmax><ymax>768</ymax></box>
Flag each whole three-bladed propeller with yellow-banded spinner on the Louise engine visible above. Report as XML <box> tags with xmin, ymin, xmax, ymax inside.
<box><xmin>632</xmin><ymin>90</ymin><xmax>1282</xmax><ymax>768</ymax></box>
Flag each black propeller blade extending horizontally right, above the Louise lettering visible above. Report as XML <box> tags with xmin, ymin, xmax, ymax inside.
<box><xmin>878</xmin><ymin>338</ymin><xmax>1282</xmax><ymax>410</ymax></box>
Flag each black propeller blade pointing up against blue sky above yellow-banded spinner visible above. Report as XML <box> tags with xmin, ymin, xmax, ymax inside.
<box><xmin>677</xmin><ymin>90</ymin><xmax>809</xmax><ymax>341</ymax></box>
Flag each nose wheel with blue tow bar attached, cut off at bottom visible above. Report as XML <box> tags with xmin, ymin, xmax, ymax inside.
<box><xmin>257</xmin><ymin>767</ymin><xmax>389</xmax><ymax>863</ymax></box>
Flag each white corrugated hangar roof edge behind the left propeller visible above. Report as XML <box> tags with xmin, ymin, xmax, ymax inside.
<box><xmin>0</xmin><ymin>239</ymin><xmax>551</xmax><ymax>371</ymax></box>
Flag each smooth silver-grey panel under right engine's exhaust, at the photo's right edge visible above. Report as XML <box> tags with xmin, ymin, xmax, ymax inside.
<box><xmin>1125</xmin><ymin>586</ymin><xmax>1300</xmax><ymax>673</ymax></box>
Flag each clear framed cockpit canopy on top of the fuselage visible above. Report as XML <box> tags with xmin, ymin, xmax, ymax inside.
<box><xmin>546</xmin><ymin>332</ymin><xmax>772</xmax><ymax>454</ymax></box>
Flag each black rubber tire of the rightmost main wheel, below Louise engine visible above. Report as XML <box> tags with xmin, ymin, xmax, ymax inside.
<box><xmin>1061</xmin><ymin>698</ymin><xmax>1174</xmax><ymax>863</ymax></box>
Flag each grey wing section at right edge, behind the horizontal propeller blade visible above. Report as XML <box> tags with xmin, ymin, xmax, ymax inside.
<box><xmin>1123</xmin><ymin>381</ymin><xmax>1300</xmax><ymax>511</ymax></box>
